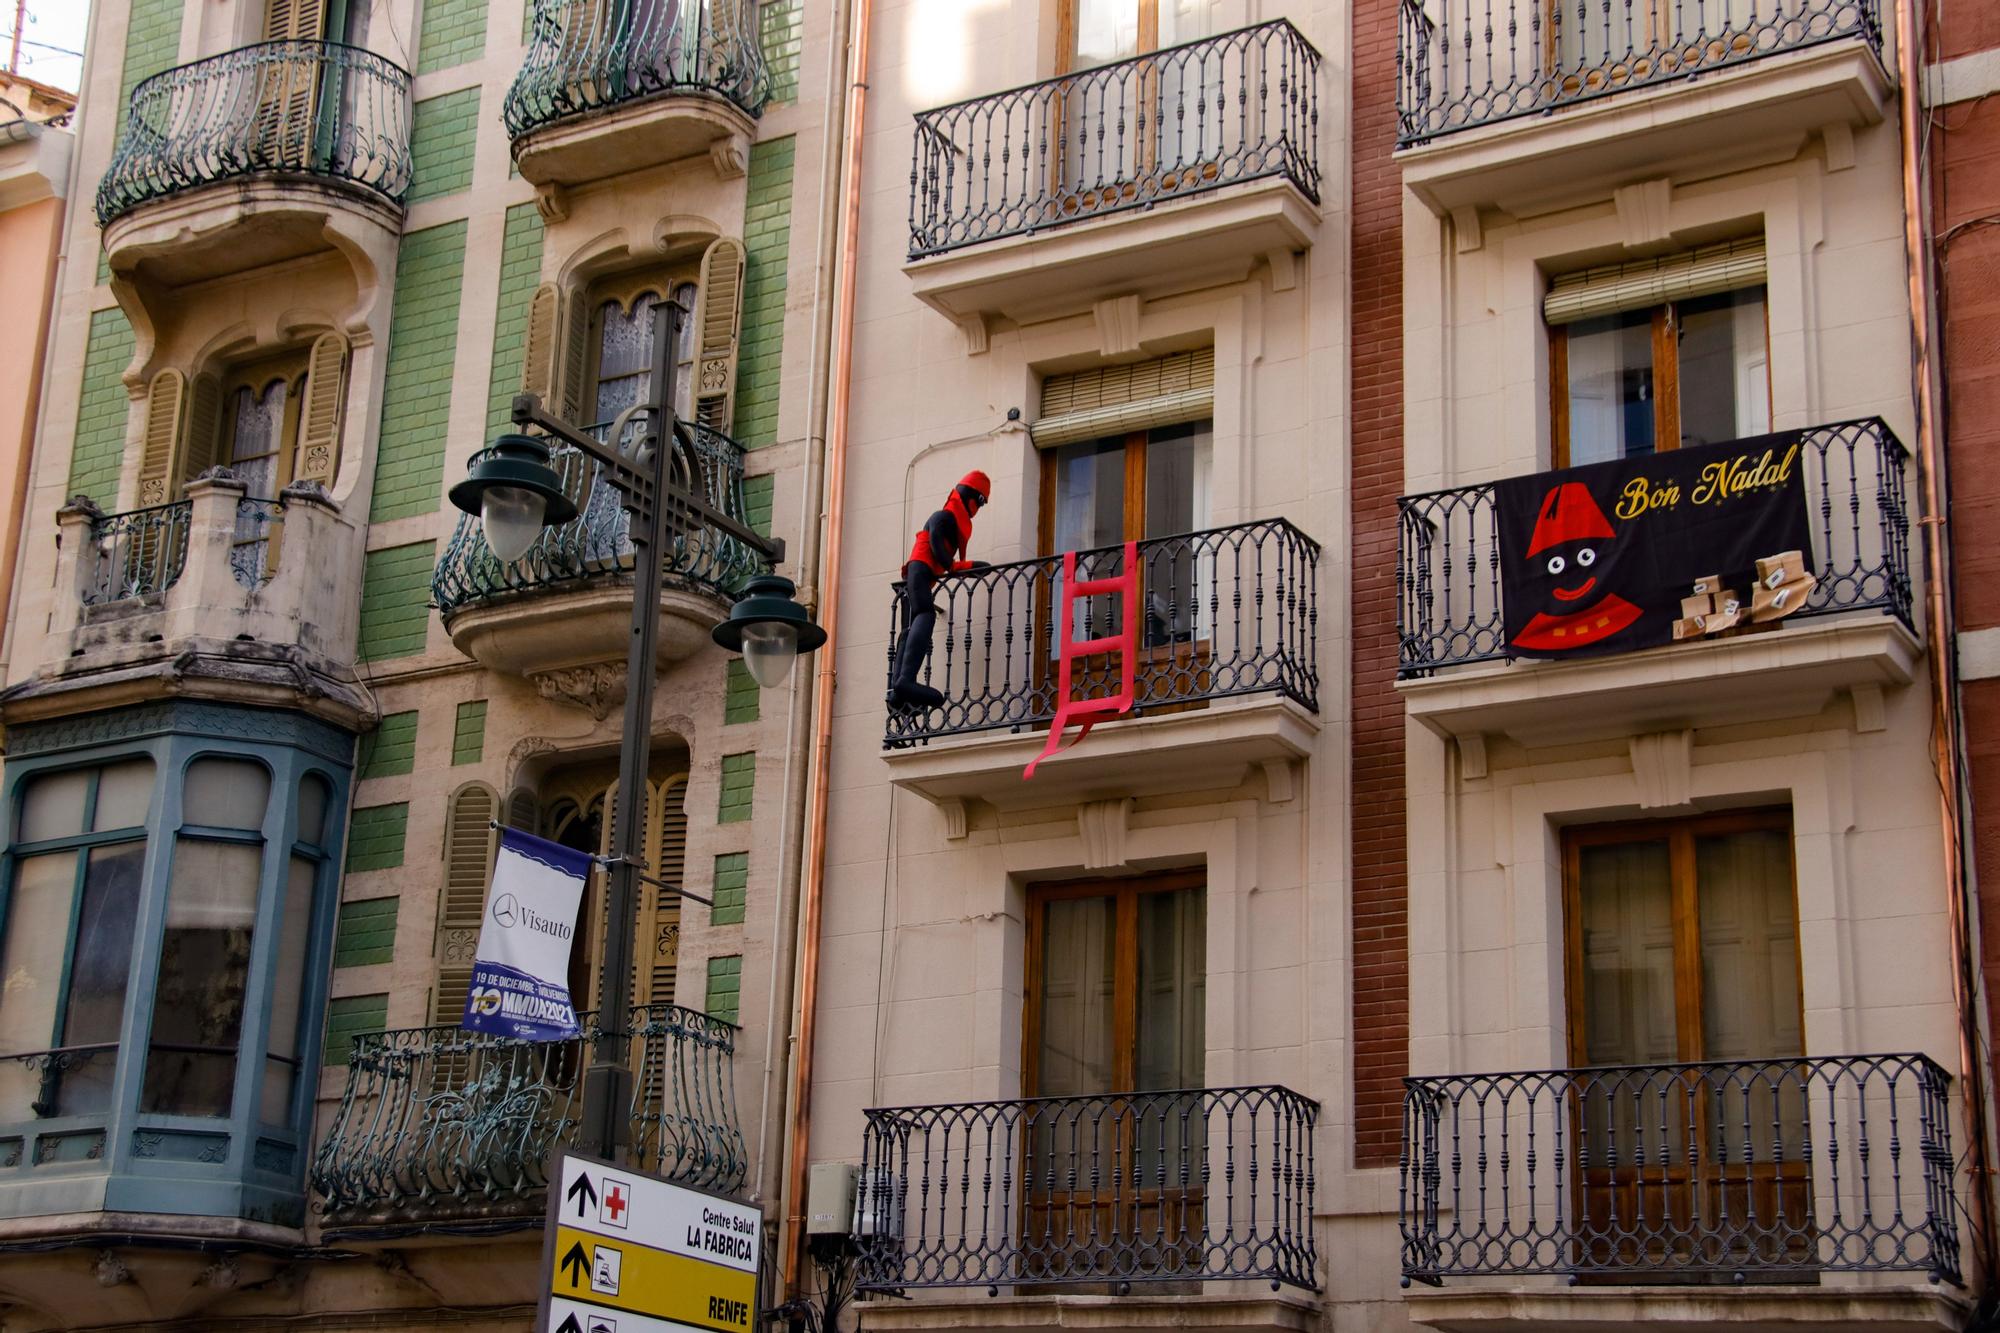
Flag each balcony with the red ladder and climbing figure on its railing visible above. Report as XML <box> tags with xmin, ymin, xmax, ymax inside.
<box><xmin>884</xmin><ymin>518</ymin><xmax>1320</xmax><ymax>805</ymax></box>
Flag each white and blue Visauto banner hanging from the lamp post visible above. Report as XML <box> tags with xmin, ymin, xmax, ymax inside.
<box><xmin>460</xmin><ymin>829</ymin><xmax>590</xmax><ymax>1041</ymax></box>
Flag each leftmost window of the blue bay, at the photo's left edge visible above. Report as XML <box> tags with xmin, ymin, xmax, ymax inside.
<box><xmin>0</xmin><ymin>759</ymin><xmax>154</xmax><ymax>1121</ymax></box>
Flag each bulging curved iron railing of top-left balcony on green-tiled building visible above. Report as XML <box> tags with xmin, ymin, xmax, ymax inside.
<box><xmin>98</xmin><ymin>42</ymin><xmax>410</xmax><ymax>226</ymax></box>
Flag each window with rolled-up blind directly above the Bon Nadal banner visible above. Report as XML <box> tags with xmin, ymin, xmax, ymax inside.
<box><xmin>1544</xmin><ymin>240</ymin><xmax>1770</xmax><ymax>468</ymax></box>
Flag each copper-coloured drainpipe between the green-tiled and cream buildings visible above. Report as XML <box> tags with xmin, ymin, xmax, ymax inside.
<box><xmin>782</xmin><ymin>0</ymin><xmax>874</xmax><ymax>1299</ymax></box>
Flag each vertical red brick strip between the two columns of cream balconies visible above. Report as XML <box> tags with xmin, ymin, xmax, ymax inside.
<box><xmin>1350</xmin><ymin>0</ymin><xmax>1410</xmax><ymax>1165</ymax></box>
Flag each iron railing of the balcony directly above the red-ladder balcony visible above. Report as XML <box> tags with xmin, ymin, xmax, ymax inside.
<box><xmin>910</xmin><ymin>18</ymin><xmax>1320</xmax><ymax>258</ymax></box>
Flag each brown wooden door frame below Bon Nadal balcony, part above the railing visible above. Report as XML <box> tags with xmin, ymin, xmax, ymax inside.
<box><xmin>1562</xmin><ymin>807</ymin><xmax>1806</xmax><ymax>1069</ymax></box>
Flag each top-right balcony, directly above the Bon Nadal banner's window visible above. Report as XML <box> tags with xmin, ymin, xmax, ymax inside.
<box><xmin>1396</xmin><ymin>0</ymin><xmax>1890</xmax><ymax>216</ymax></box>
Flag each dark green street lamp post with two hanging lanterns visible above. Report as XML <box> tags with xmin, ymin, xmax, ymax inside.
<box><xmin>452</xmin><ymin>300</ymin><xmax>826</xmax><ymax>1161</ymax></box>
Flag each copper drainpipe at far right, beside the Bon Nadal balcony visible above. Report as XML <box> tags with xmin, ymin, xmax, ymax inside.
<box><xmin>1896</xmin><ymin>0</ymin><xmax>1994</xmax><ymax>1307</ymax></box>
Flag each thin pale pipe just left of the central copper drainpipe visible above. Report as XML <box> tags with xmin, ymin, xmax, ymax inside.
<box><xmin>756</xmin><ymin>0</ymin><xmax>850</xmax><ymax>1203</ymax></box>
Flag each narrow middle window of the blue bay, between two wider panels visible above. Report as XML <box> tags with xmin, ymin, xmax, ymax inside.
<box><xmin>140</xmin><ymin>759</ymin><xmax>270</xmax><ymax>1117</ymax></box>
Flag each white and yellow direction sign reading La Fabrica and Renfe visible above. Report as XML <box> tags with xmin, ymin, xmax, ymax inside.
<box><xmin>540</xmin><ymin>1153</ymin><xmax>764</xmax><ymax>1333</ymax></box>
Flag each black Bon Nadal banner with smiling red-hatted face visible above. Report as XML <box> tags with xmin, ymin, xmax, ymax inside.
<box><xmin>1494</xmin><ymin>430</ymin><xmax>1814</xmax><ymax>656</ymax></box>
